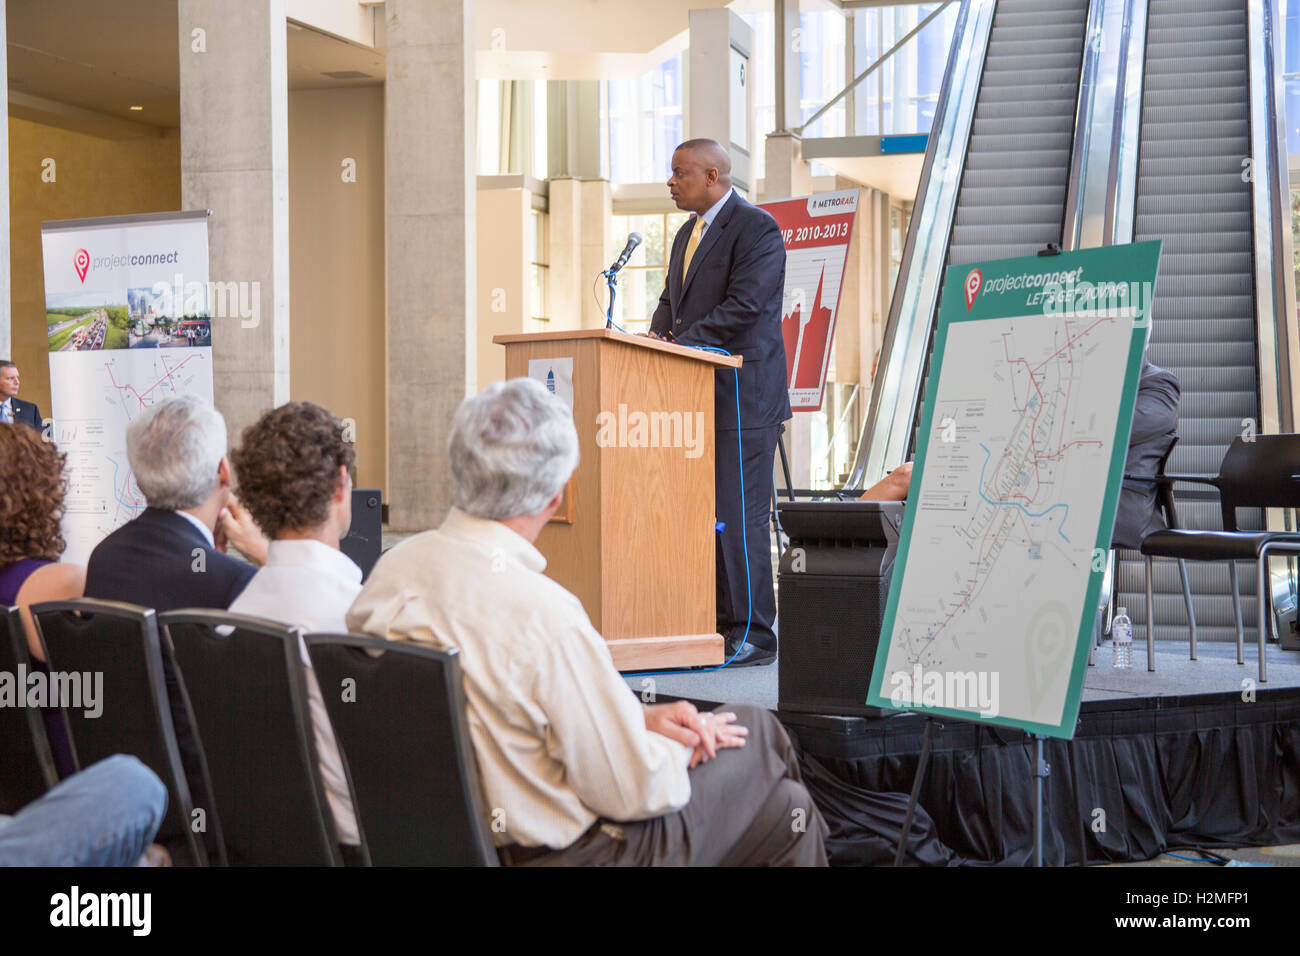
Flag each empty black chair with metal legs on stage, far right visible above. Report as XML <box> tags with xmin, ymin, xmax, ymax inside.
<box><xmin>1141</xmin><ymin>434</ymin><xmax>1300</xmax><ymax>683</ymax></box>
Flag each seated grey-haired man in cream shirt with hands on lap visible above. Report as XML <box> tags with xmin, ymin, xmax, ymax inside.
<box><xmin>347</xmin><ymin>378</ymin><xmax>827</xmax><ymax>866</ymax></box>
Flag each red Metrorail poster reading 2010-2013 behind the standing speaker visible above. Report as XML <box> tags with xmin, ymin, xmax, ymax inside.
<box><xmin>762</xmin><ymin>189</ymin><xmax>858</xmax><ymax>411</ymax></box>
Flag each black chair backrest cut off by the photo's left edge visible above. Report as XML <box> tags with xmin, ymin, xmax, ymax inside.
<box><xmin>0</xmin><ymin>607</ymin><xmax>59</xmax><ymax>814</ymax></box>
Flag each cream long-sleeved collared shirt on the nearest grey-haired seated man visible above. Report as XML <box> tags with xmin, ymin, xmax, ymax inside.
<box><xmin>347</xmin><ymin>509</ymin><xmax>690</xmax><ymax>849</ymax></box>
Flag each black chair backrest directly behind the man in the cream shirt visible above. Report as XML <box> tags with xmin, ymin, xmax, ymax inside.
<box><xmin>306</xmin><ymin>633</ymin><xmax>498</xmax><ymax>866</ymax></box>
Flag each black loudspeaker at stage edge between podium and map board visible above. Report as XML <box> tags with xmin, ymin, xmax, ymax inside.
<box><xmin>777</xmin><ymin>501</ymin><xmax>904</xmax><ymax>717</ymax></box>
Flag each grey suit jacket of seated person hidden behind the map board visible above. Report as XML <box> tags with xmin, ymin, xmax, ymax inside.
<box><xmin>1112</xmin><ymin>359</ymin><xmax>1182</xmax><ymax>548</ymax></box>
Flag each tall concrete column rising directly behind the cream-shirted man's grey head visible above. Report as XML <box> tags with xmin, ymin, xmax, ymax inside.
<box><xmin>384</xmin><ymin>0</ymin><xmax>477</xmax><ymax>531</ymax></box>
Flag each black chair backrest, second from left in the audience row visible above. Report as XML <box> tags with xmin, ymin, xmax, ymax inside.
<box><xmin>31</xmin><ymin>598</ymin><xmax>221</xmax><ymax>866</ymax></box>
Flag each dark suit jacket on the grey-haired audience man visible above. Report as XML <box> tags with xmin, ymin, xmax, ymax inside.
<box><xmin>86</xmin><ymin>507</ymin><xmax>257</xmax><ymax>613</ymax></box>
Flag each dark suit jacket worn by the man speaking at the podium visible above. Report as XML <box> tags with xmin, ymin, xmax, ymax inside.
<box><xmin>650</xmin><ymin>193</ymin><xmax>790</xmax><ymax>431</ymax></box>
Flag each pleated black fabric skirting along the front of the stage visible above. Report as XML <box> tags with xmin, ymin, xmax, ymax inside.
<box><xmin>777</xmin><ymin>688</ymin><xmax>1300</xmax><ymax>866</ymax></box>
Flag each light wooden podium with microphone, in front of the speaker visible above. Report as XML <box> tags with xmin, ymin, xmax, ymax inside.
<box><xmin>493</xmin><ymin>329</ymin><xmax>741</xmax><ymax>670</ymax></box>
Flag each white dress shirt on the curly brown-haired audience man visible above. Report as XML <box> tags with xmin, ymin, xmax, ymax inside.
<box><xmin>227</xmin><ymin>538</ymin><xmax>361</xmax><ymax>845</ymax></box>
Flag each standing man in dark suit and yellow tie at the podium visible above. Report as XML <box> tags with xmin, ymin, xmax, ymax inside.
<box><xmin>650</xmin><ymin>139</ymin><xmax>790</xmax><ymax>666</ymax></box>
